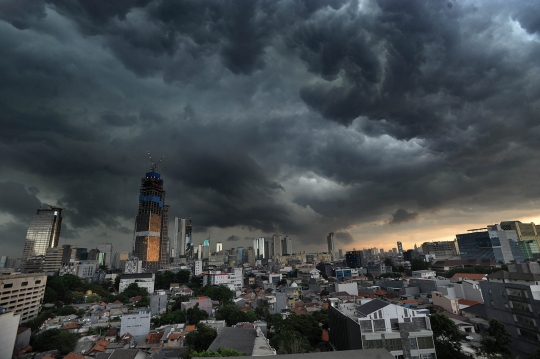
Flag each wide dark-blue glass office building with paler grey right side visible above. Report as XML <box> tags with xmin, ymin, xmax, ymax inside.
<box><xmin>456</xmin><ymin>224</ymin><xmax>523</xmax><ymax>263</ymax></box>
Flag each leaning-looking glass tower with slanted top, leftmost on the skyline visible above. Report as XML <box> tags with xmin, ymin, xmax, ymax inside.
<box><xmin>22</xmin><ymin>206</ymin><xmax>62</xmax><ymax>262</ymax></box>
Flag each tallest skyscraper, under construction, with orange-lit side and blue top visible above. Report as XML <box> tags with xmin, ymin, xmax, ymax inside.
<box><xmin>133</xmin><ymin>164</ymin><xmax>165</xmax><ymax>272</ymax></box>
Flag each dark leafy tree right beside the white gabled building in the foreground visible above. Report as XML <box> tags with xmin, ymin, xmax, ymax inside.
<box><xmin>430</xmin><ymin>313</ymin><xmax>461</xmax><ymax>359</ymax></box>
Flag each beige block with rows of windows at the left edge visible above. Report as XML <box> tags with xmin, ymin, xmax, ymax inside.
<box><xmin>0</xmin><ymin>272</ymin><xmax>47</xmax><ymax>323</ymax></box>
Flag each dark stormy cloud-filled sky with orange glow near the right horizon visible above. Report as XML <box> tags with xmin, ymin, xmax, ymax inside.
<box><xmin>0</xmin><ymin>0</ymin><xmax>540</xmax><ymax>257</ymax></box>
